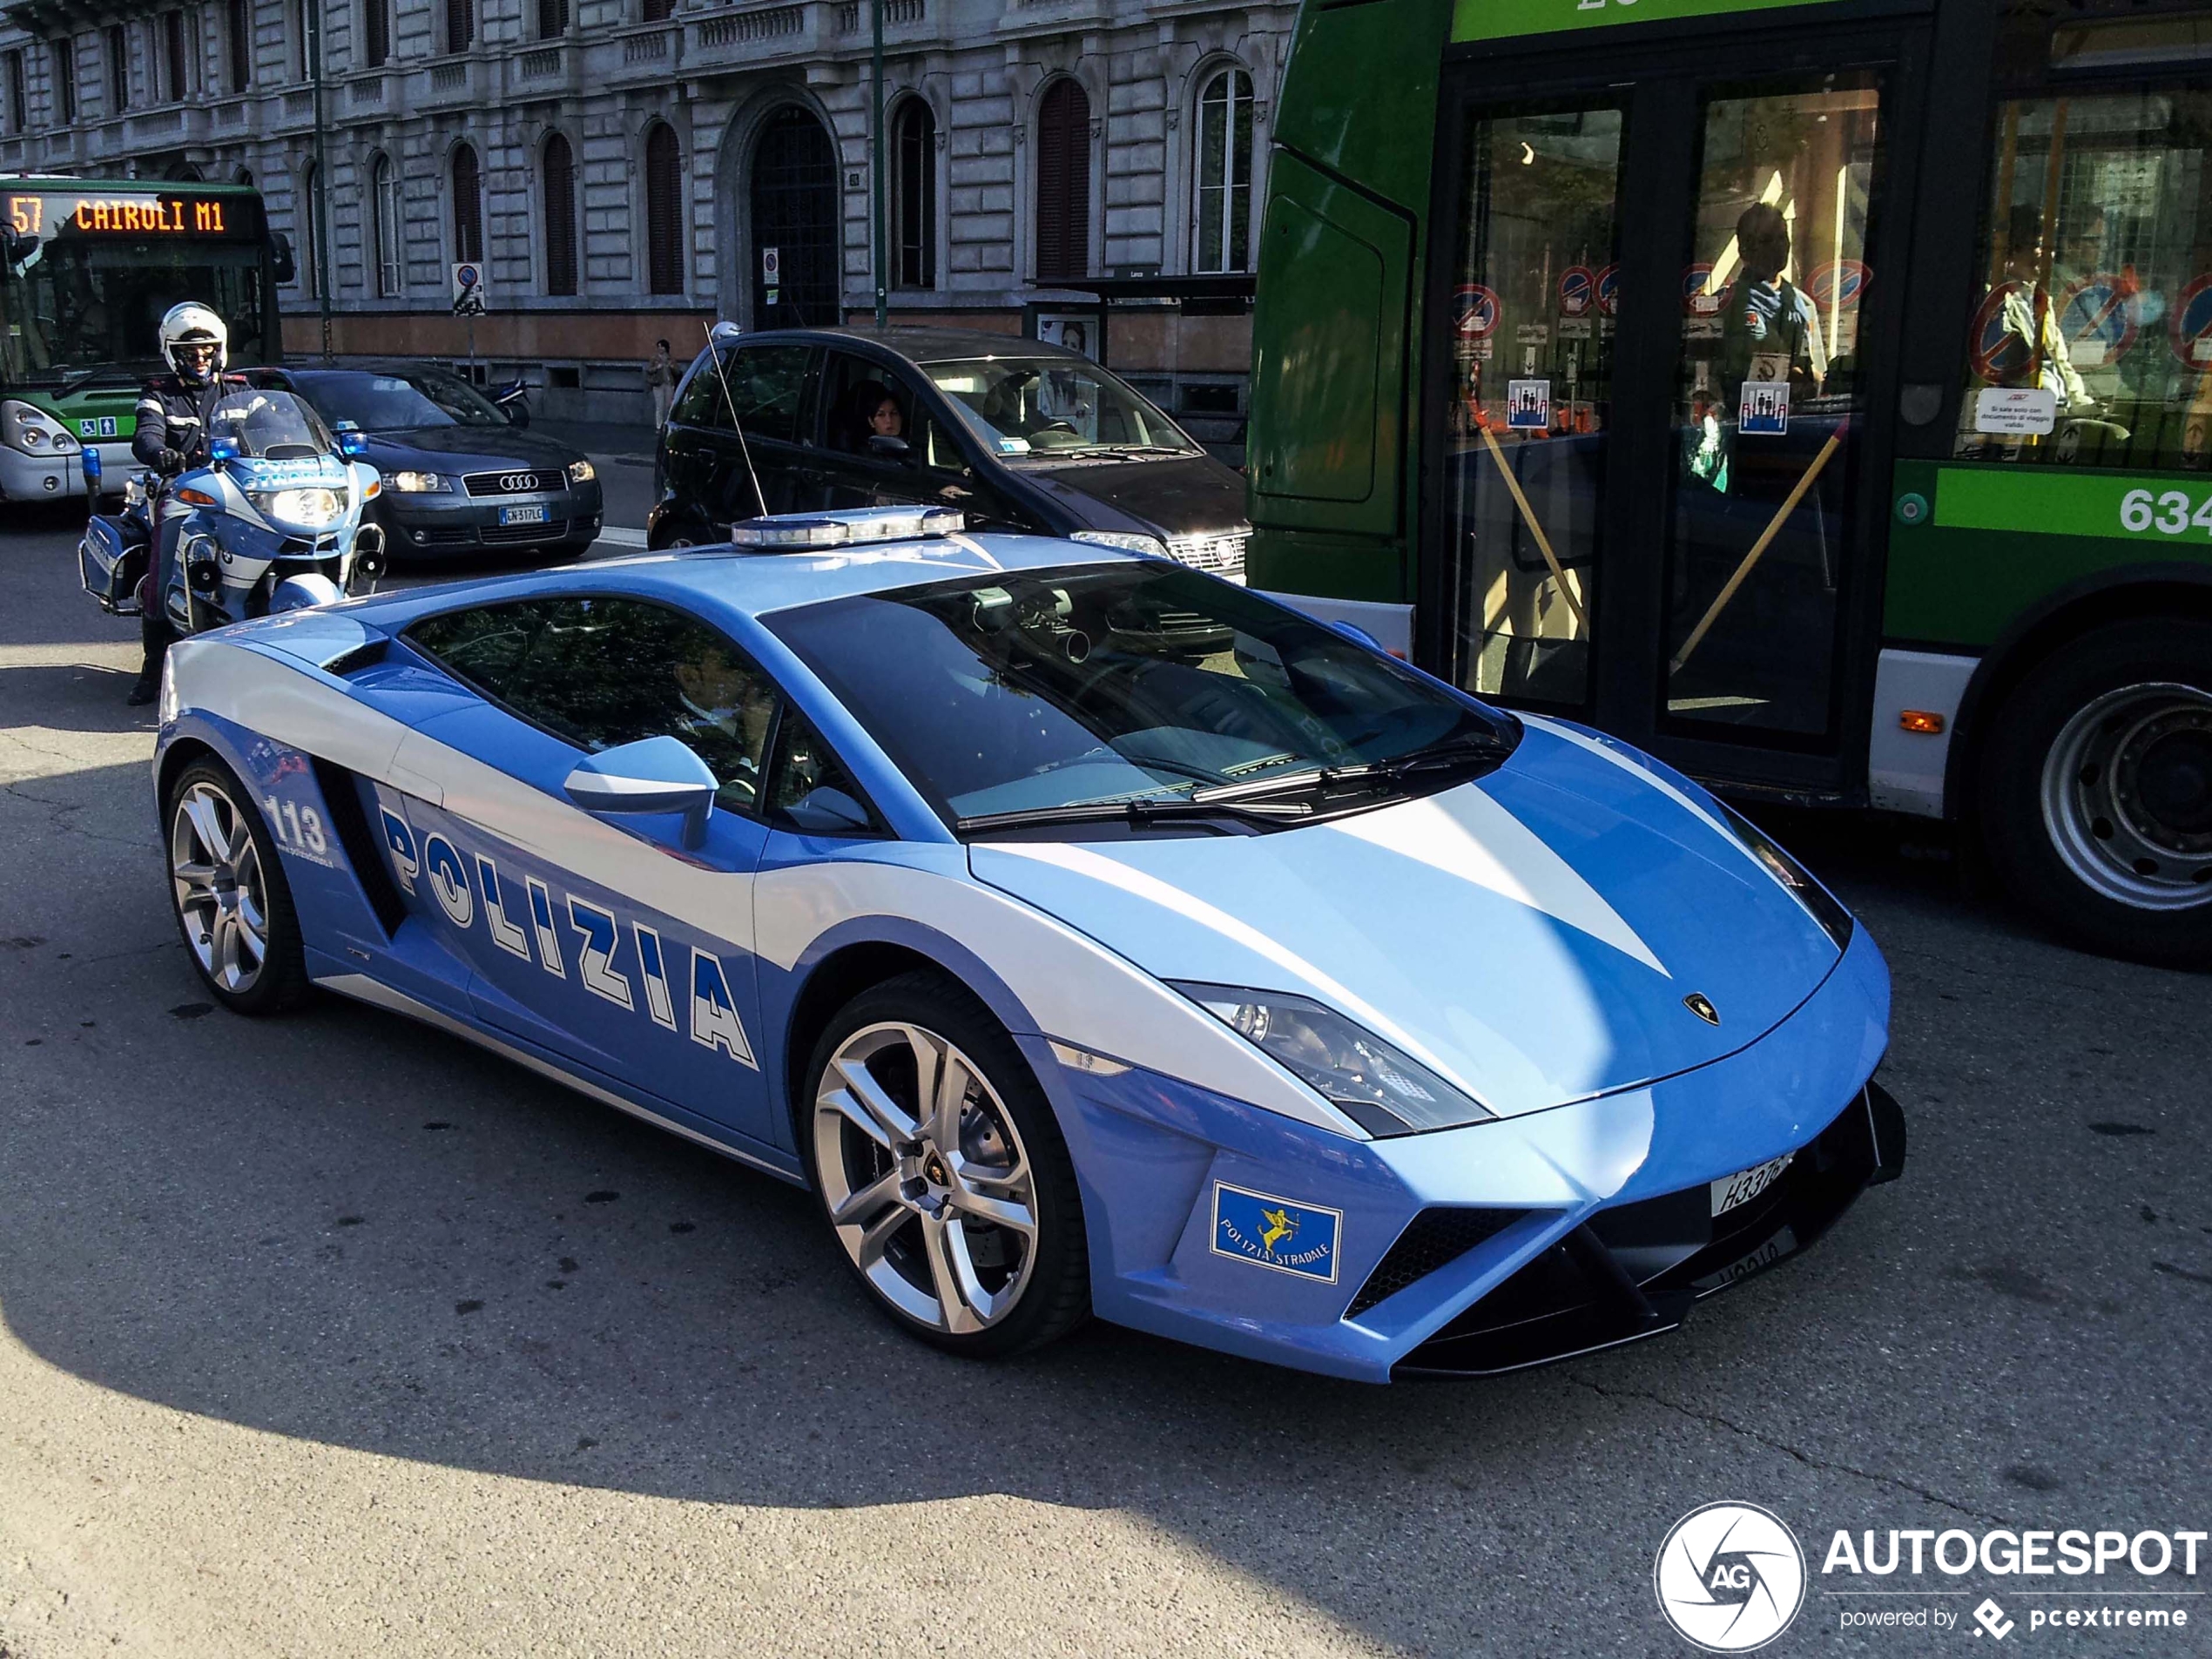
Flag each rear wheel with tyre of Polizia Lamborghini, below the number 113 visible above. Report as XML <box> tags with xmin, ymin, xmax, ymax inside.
<box><xmin>161</xmin><ymin>759</ymin><xmax>307</xmax><ymax>1015</ymax></box>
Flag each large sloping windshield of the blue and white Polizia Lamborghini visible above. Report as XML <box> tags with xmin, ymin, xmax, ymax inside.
<box><xmin>763</xmin><ymin>560</ymin><xmax>1520</xmax><ymax>832</ymax></box>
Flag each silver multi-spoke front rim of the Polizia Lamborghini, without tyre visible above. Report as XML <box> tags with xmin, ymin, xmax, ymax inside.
<box><xmin>814</xmin><ymin>1022</ymin><xmax>1037</xmax><ymax>1336</ymax></box>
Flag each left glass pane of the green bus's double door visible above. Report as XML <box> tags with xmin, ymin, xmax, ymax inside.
<box><xmin>1440</xmin><ymin>97</ymin><xmax>1622</xmax><ymax>708</ymax></box>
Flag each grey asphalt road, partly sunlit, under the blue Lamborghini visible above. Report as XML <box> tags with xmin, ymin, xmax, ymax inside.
<box><xmin>0</xmin><ymin>471</ymin><xmax>2212</xmax><ymax>1659</ymax></box>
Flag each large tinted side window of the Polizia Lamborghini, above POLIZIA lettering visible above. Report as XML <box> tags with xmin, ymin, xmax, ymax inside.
<box><xmin>407</xmin><ymin>595</ymin><xmax>777</xmax><ymax>812</ymax></box>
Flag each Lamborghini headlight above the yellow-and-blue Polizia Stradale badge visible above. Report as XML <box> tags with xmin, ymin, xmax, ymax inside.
<box><xmin>1168</xmin><ymin>980</ymin><xmax>1498</xmax><ymax>1137</ymax></box>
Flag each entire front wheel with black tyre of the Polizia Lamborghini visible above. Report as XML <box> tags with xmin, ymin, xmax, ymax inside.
<box><xmin>799</xmin><ymin>974</ymin><xmax>1090</xmax><ymax>1359</ymax></box>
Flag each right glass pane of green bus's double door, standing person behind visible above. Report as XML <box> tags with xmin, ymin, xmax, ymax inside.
<box><xmin>1666</xmin><ymin>73</ymin><xmax>1883</xmax><ymax>737</ymax></box>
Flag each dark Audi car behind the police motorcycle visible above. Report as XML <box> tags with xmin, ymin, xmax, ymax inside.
<box><xmin>253</xmin><ymin>363</ymin><xmax>604</xmax><ymax>560</ymax></box>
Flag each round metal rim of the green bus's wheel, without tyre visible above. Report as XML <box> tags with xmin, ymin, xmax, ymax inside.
<box><xmin>2041</xmin><ymin>684</ymin><xmax>2212</xmax><ymax>911</ymax></box>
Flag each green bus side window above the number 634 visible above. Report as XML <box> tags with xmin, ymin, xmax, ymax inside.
<box><xmin>1958</xmin><ymin>89</ymin><xmax>2212</xmax><ymax>469</ymax></box>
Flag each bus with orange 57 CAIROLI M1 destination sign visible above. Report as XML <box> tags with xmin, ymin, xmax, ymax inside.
<box><xmin>0</xmin><ymin>177</ymin><xmax>292</xmax><ymax>502</ymax></box>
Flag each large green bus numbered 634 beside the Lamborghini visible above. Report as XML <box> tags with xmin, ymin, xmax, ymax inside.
<box><xmin>1248</xmin><ymin>0</ymin><xmax>2212</xmax><ymax>962</ymax></box>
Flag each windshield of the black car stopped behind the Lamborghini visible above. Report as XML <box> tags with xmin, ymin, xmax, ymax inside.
<box><xmin>922</xmin><ymin>356</ymin><xmax>1201</xmax><ymax>458</ymax></box>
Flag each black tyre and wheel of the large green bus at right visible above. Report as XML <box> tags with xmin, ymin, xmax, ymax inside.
<box><xmin>1979</xmin><ymin>619</ymin><xmax>2212</xmax><ymax>967</ymax></box>
